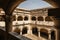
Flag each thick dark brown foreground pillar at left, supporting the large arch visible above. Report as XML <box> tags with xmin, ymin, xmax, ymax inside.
<box><xmin>5</xmin><ymin>14</ymin><xmax>12</xmax><ymax>32</ymax></box>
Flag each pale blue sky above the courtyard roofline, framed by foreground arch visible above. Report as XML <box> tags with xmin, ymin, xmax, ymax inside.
<box><xmin>18</xmin><ymin>0</ymin><xmax>52</xmax><ymax>10</ymax></box>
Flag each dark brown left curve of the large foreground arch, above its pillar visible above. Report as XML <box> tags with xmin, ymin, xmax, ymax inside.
<box><xmin>3</xmin><ymin>0</ymin><xmax>25</xmax><ymax>13</ymax></box>
